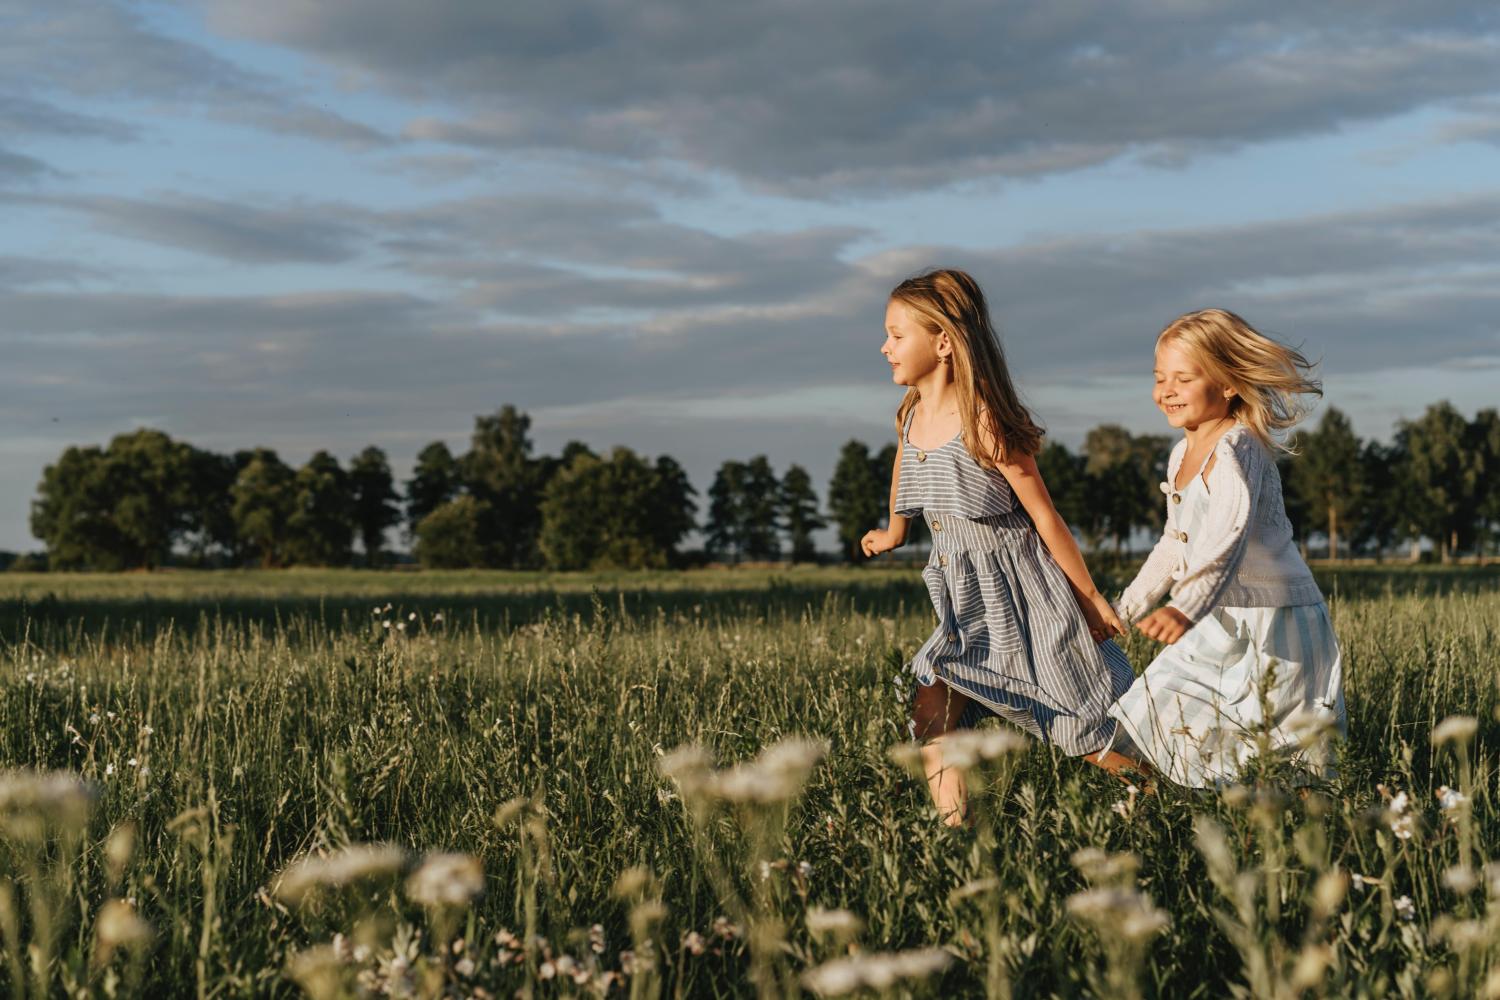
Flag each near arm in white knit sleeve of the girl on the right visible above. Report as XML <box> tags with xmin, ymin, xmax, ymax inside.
<box><xmin>1167</xmin><ymin>432</ymin><xmax>1269</xmax><ymax>622</ymax></box>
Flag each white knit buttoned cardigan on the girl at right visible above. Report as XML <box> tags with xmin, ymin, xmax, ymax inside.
<box><xmin>1116</xmin><ymin>424</ymin><xmax>1323</xmax><ymax>622</ymax></box>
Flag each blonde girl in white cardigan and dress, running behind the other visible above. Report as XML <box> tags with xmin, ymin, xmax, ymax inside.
<box><xmin>1110</xmin><ymin>309</ymin><xmax>1346</xmax><ymax>787</ymax></box>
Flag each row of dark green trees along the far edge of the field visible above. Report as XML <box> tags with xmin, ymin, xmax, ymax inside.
<box><xmin>23</xmin><ymin>402</ymin><xmax>1500</xmax><ymax>570</ymax></box>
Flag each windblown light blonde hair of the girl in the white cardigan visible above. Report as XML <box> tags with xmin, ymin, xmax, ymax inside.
<box><xmin>1157</xmin><ymin>309</ymin><xmax>1323</xmax><ymax>451</ymax></box>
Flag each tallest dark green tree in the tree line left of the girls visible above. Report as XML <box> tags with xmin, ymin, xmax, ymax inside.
<box><xmin>462</xmin><ymin>405</ymin><xmax>542</xmax><ymax>568</ymax></box>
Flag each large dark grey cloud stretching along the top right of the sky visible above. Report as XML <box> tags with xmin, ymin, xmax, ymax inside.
<box><xmin>210</xmin><ymin>0</ymin><xmax>1500</xmax><ymax>195</ymax></box>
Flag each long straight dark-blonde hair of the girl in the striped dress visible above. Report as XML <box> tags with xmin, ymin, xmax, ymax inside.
<box><xmin>891</xmin><ymin>268</ymin><xmax>1043</xmax><ymax>469</ymax></box>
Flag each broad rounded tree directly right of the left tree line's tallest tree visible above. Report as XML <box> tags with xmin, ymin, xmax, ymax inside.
<box><xmin>539</xmin><ymin>448</ymin><xmax>692</xmax><ymax>570</ymax></box>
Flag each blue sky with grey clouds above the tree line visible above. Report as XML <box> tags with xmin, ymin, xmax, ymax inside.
<box><xmin>0</xmin><ymin>0</ymin><xmax>1500</xmax><ymax>550</ymax></box>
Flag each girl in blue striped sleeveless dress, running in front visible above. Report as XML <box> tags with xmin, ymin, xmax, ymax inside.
<box><xmin>860</xmin><ymin>270</ymin><xmax>1134</xmax><ymax>825</ymax></box>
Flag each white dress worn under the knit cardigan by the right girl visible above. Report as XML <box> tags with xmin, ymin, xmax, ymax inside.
<box><xmin>1110</xmin><ymin>455</ymin><xmax>1346</xmax><ymax>787</ymax></box>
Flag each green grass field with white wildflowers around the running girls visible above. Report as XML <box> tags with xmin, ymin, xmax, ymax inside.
<box><xmin>0</xmin><ymin>567</ymin><xmax>1500</xmax><ymax>997</ymax></box>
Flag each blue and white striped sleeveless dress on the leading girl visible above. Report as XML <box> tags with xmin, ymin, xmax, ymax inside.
<box><xmin>896</xmin><ymin>418</ymin><xmax>1136</xmax><ymax>756</ymax></box>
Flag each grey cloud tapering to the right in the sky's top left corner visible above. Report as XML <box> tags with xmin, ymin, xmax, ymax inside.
<box><xmin>0</xmin><ymin>0</ymin><xmax>392</xmax><ymax>148</ymax></box>
